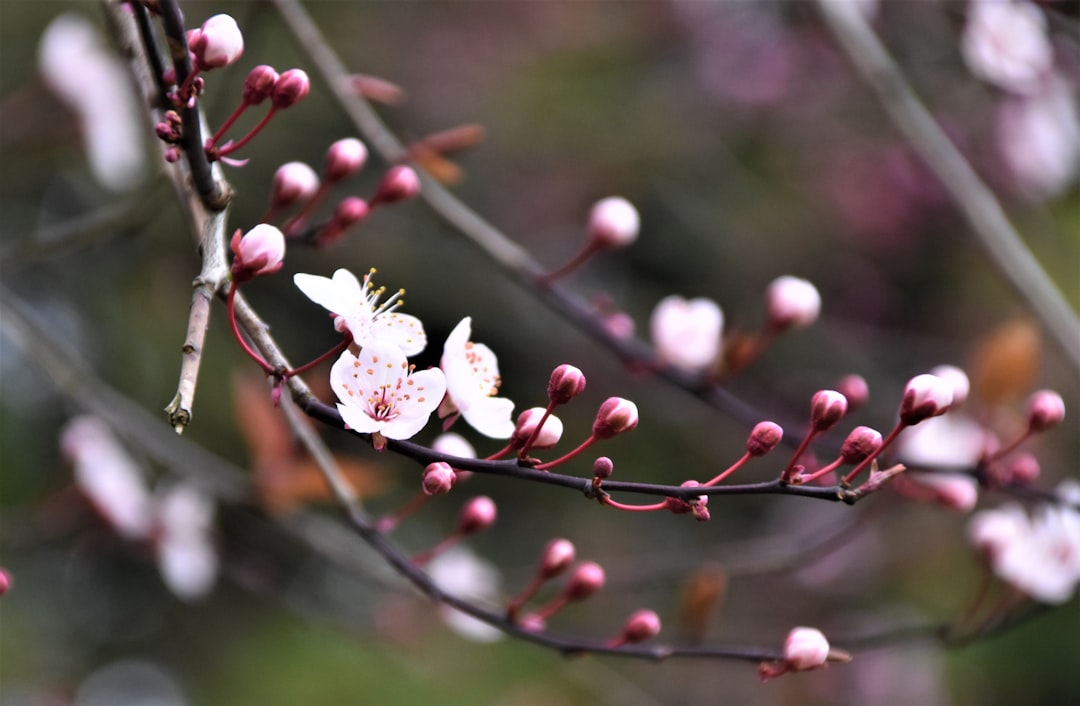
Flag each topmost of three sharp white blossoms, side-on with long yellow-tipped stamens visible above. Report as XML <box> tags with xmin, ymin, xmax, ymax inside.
<box><xmin>293</xmin><ymin>268</ymin><xmax>429</xmax><ymax>354</ymax></box>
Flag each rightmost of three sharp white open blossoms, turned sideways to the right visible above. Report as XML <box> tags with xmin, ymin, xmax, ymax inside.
<box><xmin>438</xmin><ymin>316</ymin><xmax>514</xmax><ymax>438</ymax></box>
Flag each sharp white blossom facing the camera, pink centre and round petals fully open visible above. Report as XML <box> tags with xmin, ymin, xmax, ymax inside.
<box><xmin>330</xmin><ymin>340</ymin><xmax>446</xmax><ymax>439</ymax></box>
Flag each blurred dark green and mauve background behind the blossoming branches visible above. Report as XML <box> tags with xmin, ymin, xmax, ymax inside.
<box><xmin>0</xmin><ymin>0</ymin><xmax>1080</xmax><ymax>705</ymax></box>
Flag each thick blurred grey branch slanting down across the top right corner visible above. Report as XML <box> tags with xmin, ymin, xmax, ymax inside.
<box><xmin>816</xmin><ymin>0</ymin><xmax>1080</xmax><ymax>371</ymax></box>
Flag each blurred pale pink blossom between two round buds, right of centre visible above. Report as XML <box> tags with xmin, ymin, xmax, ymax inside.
<box><xmin>649</xmin><ymin>295</ymin><xmax>724</xmax><ymax>370</ymax></box>
